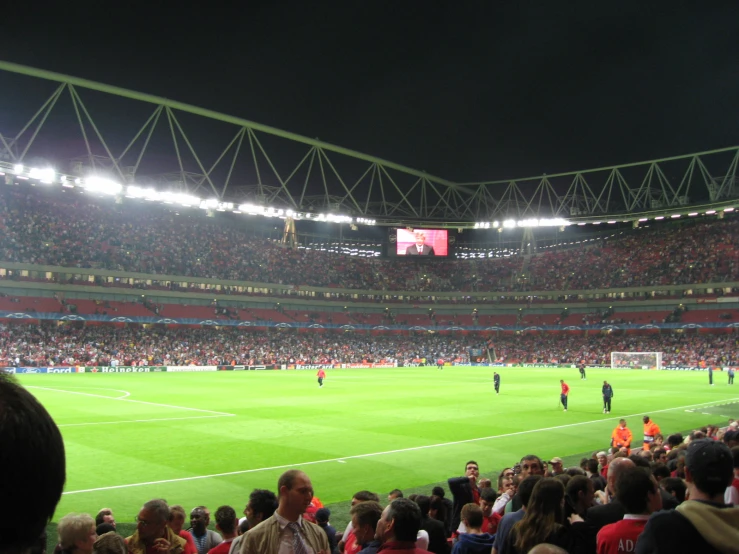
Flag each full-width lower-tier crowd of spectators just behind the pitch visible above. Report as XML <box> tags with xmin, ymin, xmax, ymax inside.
<box><xmin>0</xmin><ymin>322</ymin><xmax>739</xmax><ymax>367</ymax></box>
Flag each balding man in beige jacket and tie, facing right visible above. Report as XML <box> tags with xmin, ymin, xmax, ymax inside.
<box><xmin>241</xmin><ymin>469</ymin><xmax>329</xmax><ymax>554</ymax></box>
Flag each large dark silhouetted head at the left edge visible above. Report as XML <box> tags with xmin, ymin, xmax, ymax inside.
<box><xmin>0</xmin><ymin>370</ymin><xmax>66</xmax><ymax>554</ymax></box>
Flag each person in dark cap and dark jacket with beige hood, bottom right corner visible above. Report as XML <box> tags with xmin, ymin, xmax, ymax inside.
<box><xmin>636</xmin><ymin>439</ymin><xmax>739</xmax><ymax>554</ymax></box>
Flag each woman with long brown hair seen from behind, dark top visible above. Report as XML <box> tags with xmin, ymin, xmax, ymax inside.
<box><xmin>505</xmin><ymin>478</ymin><xmax>594</xmax><ymax>554</ymax></box>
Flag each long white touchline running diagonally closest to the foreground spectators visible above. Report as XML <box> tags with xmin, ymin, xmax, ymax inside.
<box><xmin>62</xmin><ymin>399</ymin><xmax>739</xmax><ymax>494</ymax></box>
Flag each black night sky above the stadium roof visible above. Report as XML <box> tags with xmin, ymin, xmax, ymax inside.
<box><xmin>0</xmin><ymin>0</ymin><xmax>739</xmax><ymax>181</ymax></box>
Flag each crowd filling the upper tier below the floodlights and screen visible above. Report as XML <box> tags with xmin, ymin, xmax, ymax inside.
<box><xmin>0</xmin><ymin>189</ymin><xmax>739</xmax><ymax>292</ymax></box>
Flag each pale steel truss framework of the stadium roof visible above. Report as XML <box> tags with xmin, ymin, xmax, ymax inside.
<box><xmin>0</xmin><ymin>61</ymin><xmax>739</xmax><ymax>228</ymax></box>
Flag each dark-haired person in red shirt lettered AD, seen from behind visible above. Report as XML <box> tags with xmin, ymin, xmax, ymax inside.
<box><xmin>597</xmin><ymin>467</ymin><xmax>662</xmax><ymax>554</ymax></box>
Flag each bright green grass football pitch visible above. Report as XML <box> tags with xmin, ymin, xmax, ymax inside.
<box><xmin>19</xmin><ymin>367</ymin><xmax>739</xmax><ymax>522</ymax></box>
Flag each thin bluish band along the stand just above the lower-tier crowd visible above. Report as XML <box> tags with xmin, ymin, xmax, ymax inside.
<box><xmin>0</xmin><ymin>311</ymin><xmax>739</xmax><ymax>332</ymax></box>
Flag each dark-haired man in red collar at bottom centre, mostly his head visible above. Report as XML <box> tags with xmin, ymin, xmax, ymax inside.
<box><xmin>375</xmin><ymin>498</ymin><xmax>428</xmax><ymax>554</ymax></box>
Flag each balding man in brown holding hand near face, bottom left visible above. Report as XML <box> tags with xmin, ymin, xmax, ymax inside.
<box><xmin>126</xmin><ymin>499</ymin><xmax>187</xmax><ymax>554</ymax></box>
